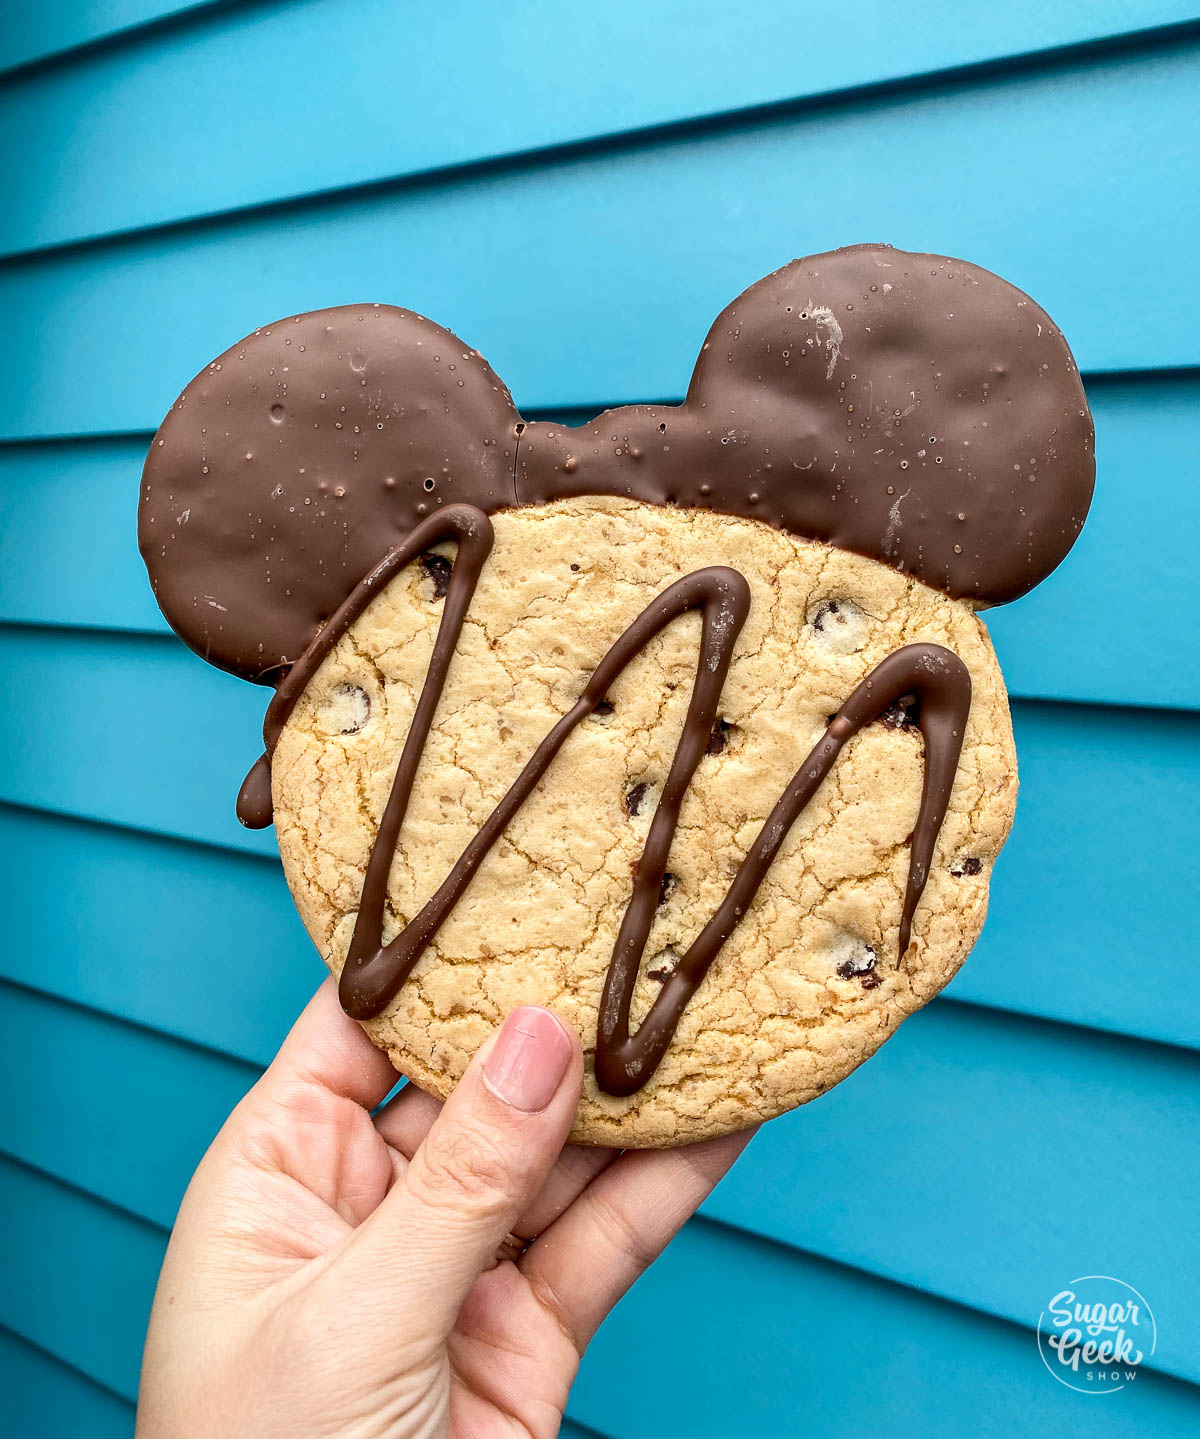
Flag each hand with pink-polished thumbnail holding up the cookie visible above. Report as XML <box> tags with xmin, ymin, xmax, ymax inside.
<box><xmin>138</xmin><ymin>981</ymin><xmax>748</xmax><ymax>1439</ymax></box>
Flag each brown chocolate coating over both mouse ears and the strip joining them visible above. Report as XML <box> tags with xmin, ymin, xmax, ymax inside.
<box><xmin>138</xmin><ymin>245</ymin><xmax>1095</xmax><ymax>684</ymax></box>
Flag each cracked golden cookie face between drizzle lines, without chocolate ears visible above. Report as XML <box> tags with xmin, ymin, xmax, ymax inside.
<box><xmin>272</xmin><ymin>498</ymin><xmax>1017</xmax><ymax>1147</ymax></box>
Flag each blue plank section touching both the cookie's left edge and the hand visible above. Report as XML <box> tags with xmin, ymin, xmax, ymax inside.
<box><xmin>0</xmin><ymin>806</ymin><xmax>315</xmax><ymax>1066</ymax></box>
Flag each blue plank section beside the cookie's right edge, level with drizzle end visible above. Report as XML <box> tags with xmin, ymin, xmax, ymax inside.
<box><xmin>948</xmin><ymin>704</ymin><xmax>1200</xmax><ymax>1048</ymax></box>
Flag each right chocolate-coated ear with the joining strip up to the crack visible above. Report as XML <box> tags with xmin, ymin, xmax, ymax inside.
<box><xmin>517</xmin><ymin>245</ymin><xmax>1095</xmax><ymax>604</ymax></box>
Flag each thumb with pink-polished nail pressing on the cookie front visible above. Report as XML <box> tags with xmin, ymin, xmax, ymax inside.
<box><xmin>336</xmin><ymin>1006</ymin><xmax>583</xmax><ymax>1344</ymax></box>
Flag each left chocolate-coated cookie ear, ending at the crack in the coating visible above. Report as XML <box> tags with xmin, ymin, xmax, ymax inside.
<box><xmin>138</xmin><ymin>305</ymin><xmax>521</xmax><ymax>682</ymax></box>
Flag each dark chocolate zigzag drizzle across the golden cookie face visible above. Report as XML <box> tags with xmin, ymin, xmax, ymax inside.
<box><xmin>237</xmin><ymin>505</ymin><xmax>971</xmax><ymax>1095</ymax></box>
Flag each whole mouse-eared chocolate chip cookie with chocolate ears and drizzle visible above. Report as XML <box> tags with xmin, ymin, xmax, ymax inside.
<box><xmin>140</xmin><ymin>245</ymin><xmax>1095</xmax><ymax>1147</ymax></box>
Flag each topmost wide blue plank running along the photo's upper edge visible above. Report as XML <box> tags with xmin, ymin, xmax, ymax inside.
<box><xmin>0</xmin><ymin>0</ymin><xmax>1197</xmax><ymax>253</ymax></box>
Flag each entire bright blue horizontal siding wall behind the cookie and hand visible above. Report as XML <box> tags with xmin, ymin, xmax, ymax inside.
<box><xmin>0</xmin><ymin>0</ymin><xmax>1200</xmax><ymax>1439</ymax></box>
